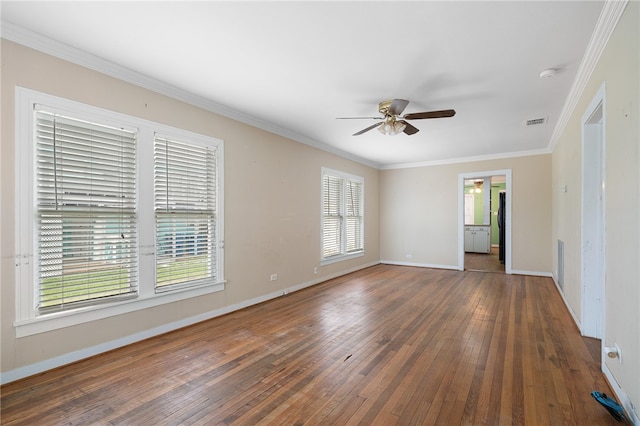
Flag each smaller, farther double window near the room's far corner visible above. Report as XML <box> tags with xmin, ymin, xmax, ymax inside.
<box><xmin>321</xmin><ymin>168</ymin><xmax>364</xmax><ymax>264</ymax></box>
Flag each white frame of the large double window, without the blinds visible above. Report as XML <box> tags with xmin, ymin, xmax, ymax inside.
<box><xmin>14</xmin><ymin>87</ymin><xmax>225</xmax><ymax>337</ymax></box>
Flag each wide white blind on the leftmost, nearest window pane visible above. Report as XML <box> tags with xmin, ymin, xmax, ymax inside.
<box><xmin>35</xmin><ymin>110</ymin><xmax>138</xmax><ymax>313</ymax></box>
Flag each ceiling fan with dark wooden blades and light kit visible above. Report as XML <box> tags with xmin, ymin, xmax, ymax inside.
<box><xmin>338</xmin><ymin>99</ymin><xmax>456</xmax><ymax>136</ymax></box>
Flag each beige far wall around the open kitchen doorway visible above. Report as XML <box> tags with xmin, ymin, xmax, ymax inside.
<box><xmin>380</xmin><ymin>155</ymin><xmax>551</xmax><ymax>274</ymax></box>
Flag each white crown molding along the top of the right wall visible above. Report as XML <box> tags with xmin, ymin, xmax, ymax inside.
<box><xmin>549</xmin><ymin>0</ymin><xmax>629</xmax><ymax>152</ymax></box>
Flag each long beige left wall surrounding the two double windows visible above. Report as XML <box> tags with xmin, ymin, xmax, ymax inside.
<box><xmin>0</xmin><ymin>40</ymin><xmax>380</xmax><ymax>372</ymax></box>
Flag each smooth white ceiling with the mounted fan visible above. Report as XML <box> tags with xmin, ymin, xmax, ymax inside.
<box><xmin>1</xmin><ymin>1</ymin><xmax>604</xmax><ymax>168</ymax></box>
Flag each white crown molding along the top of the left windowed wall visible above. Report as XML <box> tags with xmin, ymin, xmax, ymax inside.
<box><xmin>0</xmin><ymin>21</ymin><xmax>380</xmax><ymax>169</ymax></box>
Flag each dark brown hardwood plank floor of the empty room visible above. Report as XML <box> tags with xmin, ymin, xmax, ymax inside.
<box><xmin>1</xmin><ymin>265</ymin><xmax>618</xmax><ymax>426</ymax></box>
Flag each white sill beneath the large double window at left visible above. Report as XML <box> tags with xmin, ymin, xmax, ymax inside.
<box><xmin>14</xmin><ymin>281</ymin><xmax>224</xmax><ymax>338</ymax></box>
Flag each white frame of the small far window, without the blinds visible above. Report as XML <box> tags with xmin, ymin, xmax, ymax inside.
<box><xmin>320</xmin><ymin>167</ymin><xmax>365</xmax><ymax>265</ymax></box>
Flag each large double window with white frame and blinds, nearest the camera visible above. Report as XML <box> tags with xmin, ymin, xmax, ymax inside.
<box><xmin>15</xmin><ymin>88</ymin><xmax>224</xmax><ymax>337</ymax></box>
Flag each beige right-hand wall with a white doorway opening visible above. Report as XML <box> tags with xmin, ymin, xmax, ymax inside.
<box><xmin>551</xmin><ymin>1</ymin><xmax>640</xmax><ymax>415</ymax></box>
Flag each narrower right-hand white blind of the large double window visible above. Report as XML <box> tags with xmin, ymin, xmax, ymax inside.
<box><xmin>154</xmin><ymin>135</ymin><xmax>217</xmax><ymax>290</ymax></box>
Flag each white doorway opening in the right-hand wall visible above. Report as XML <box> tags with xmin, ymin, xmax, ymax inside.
<box><xmin>580</xmin><ymin>85</ymin><xmax>605</xmax><ymax>339</ymax></box>
